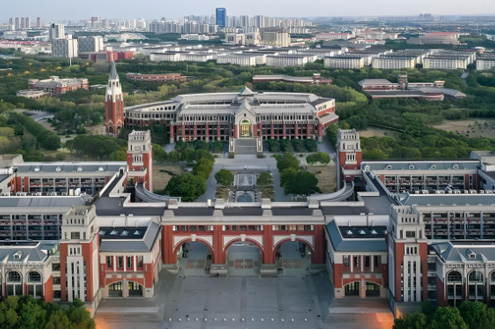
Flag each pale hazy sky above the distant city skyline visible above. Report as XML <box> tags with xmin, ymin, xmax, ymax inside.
<box><xmin>0</xmin><ymin>0</ymin><xmax>495</xmax><ymax>22</ymax></box>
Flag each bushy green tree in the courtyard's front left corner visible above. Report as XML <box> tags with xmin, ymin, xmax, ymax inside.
<box><xmin>164</xmin><ymin>173</ymin><xmax>206</xmax><ymax>202</ymax></box>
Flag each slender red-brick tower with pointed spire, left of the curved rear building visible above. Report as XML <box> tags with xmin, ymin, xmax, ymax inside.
<box><xmin>105</xmin><ymin>61</ymin><xmax>124</xmax><ymax>135</ymax></box>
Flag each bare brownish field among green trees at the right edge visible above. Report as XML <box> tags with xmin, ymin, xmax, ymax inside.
<box><xmin>433</xmin><ymin>119</ymin><xmax>495</xmax><ymax>138</ymax></box>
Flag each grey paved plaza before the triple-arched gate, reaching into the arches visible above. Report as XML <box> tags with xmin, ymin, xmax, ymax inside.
<box><xmin>96</xmin><ymin>243</ymin><xmax>392</xmax><ymax>329</ymax></box>
